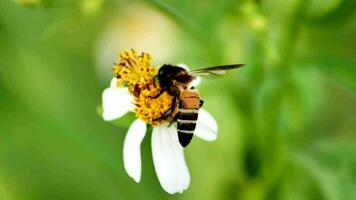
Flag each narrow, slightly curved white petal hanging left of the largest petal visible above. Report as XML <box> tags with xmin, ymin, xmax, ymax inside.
<box><xmin>123</xmin><ymin>119</ymin><xmax>146</xmax><ymax>182</ymax></box>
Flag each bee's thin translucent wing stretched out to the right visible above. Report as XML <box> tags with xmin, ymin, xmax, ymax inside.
<box><xmin>189</xmin><ymin>64</ymin><xmax>244</xmax><ymax>77</ymax></box>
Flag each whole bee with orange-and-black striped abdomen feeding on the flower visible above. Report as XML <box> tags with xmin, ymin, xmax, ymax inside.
<box><xmin>151</xmin><ymin>64</ymin><xmax>243</xmax><ymax>147</ymax></box>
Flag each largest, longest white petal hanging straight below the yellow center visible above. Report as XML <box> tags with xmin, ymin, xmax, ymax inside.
<box><xmin>151</xmin><ymin>126</ymin><xmax>190</xmax><ymax>194</ymax></box>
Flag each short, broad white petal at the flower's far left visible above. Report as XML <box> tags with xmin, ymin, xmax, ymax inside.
<box><xmin>102</xmin><ymin>87</ymin><xmax>134</xmax><ymax>121</ymax></box>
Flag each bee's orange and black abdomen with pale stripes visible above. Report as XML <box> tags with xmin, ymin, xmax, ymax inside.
<box><xmin>177</xmin><ymin>90</ymin><xmax>200</xmax><ymax>147</ymax></box>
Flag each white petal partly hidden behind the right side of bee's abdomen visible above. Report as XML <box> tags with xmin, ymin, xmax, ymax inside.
<box><xmin>194</xmin><ymin>108</ymin><xmax>218</xmax><ymax>141</ymax></box>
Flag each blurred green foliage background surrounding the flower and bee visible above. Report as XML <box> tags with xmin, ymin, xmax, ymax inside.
<box><xmin>0</xmin><ymin>0</ymin><xmax>356</xmax><ymax>200</ymax></box>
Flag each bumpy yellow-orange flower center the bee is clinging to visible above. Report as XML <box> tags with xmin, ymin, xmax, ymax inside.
<box><xmin>113</xmin><ymin>49</ymin><xmax>178</xmax><ymax>126</ymax></box>
